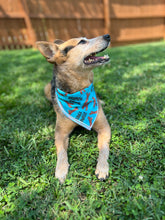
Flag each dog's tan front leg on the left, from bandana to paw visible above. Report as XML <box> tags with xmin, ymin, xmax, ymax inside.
<box><xmin>55</xmin><ymin>114</ymin><xmax>75</xmax><ymax>183</ymax></box>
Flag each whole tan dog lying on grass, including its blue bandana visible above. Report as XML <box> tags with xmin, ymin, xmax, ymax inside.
<box><xmin>36</xmin><ymin>34</ymin><xmax>111</xmax><ymax>183</ymax></box>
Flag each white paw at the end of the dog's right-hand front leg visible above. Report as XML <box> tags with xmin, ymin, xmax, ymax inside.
<box><xmin>95</xmin><ymin>162</ymin><xmax>109</xmax><ymax>181</ymax></box>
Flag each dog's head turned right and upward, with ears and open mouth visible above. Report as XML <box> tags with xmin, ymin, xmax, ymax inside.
<box><xmin>36</xmin><ymin>34</ymin><xmax>110</xmax><ymax>70</ymax></box>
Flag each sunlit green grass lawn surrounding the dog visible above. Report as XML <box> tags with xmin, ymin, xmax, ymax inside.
<box><xmin>0</xmin><ymin>42</ymin><xmax>165</xmax><ymax>220</ymax></box>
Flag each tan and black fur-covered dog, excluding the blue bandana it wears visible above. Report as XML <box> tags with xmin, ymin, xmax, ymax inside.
<box><xmin>36</xmin><ymin>34</ymin><xmax>111</xmax><ymax>183</ymax></box>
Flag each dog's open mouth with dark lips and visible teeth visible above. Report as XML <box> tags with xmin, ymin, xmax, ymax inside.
<box><xmin>84</xmin><ymin>47</ymin><xmax>110</xmax><ymax>65</ymax></box>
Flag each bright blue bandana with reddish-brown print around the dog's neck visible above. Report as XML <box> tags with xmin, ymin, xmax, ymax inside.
<box><xmin>55</xmin><ymin>83</ymin><xmax>98</xmax><ymax>130</ymax></box>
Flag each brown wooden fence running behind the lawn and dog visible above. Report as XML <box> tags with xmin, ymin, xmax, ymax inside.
<box><xmin>0</xmin><ymin>0</ymin><xmax>165</xmax><ymax>49</ymax></box>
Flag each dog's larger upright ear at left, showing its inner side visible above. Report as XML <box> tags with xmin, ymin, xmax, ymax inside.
<box><xmin>36</xmin><ymin>41</ymin><xmax>58</xmax><ymax>63</ymax></box>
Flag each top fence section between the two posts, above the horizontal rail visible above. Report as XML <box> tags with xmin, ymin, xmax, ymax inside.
<box><xmin>27</xmin><ymin>0</ymin><xmax>104</xmax><ymax>19</ymax></box>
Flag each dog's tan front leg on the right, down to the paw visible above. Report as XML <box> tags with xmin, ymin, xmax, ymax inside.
<box><xmin>93</xmin><ymin>106</ymin><xmax>111</xmax><ymax>180</ymax></box>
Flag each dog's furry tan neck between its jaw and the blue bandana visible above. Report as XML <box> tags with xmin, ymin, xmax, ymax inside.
<box><xmin>53</xmin><ymin>65</ymin><xmax>93</xmax><ymax>93</ymax></box>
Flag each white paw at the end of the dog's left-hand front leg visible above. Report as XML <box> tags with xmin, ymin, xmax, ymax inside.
<box><xmin>55</xmin><ymin>163</ymin><xmax>69</xmax><ymax>184</ymax></box>
